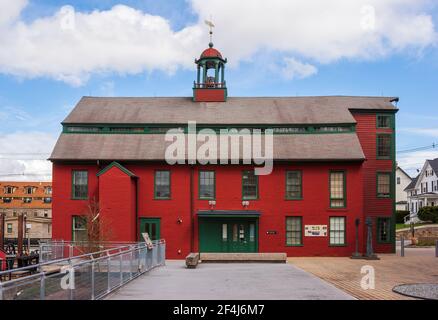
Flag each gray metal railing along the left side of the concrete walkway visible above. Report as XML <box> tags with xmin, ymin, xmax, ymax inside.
<box><xmin>0</xmin><ymin>240</ymin><xmax>166</xmax><ymax>300</ymax></box>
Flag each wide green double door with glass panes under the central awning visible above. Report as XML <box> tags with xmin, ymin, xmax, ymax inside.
<box><xmin>199</xmin><ymin>218</ymin><xmax>258</xmax><ymax>252</ymax></box>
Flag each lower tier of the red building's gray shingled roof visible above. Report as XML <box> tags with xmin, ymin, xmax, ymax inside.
<box><xmin>50</xmin><ymin>133</ymin><xmax>365</xmax><ymax>161</ymax></box>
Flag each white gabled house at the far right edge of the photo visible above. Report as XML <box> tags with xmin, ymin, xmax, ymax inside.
<box><xmin>405</xmin><ymin>158</ymin><xmax>438</xmax><ymax>222</ymax></box>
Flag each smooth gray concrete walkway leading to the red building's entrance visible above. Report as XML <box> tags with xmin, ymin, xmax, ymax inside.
<box><xmin>108</xmin><ymin>260</ymin><xmax>354</xmax><ymax>300</ymax></box>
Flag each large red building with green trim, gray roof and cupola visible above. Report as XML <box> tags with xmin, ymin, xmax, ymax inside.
<box><xmin>50</xmin><ymin>44</ymin><xmax>398</xmax><ymax>258</ymax></box>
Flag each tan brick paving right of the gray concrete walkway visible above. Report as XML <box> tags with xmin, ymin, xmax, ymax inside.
<box><xmin>288</xmin><ymin>248</ymin><xmax>438</xmax><ymax>300</ymax></box>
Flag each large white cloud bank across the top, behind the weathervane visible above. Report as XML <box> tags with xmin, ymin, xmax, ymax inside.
<box><xmin>0</xmin><ymin>0</ymin><xmax>436</xmax><ymax>85</ymax></box>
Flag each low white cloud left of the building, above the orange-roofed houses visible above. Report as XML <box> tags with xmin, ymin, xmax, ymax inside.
<box><xmin>0</xmin><ymin>132</ymin><xmax>56</xmax><ymax>181</ymax></box>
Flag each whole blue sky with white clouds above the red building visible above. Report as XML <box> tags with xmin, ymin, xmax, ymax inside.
<box><xmin>0</xmin><ymin>0</ymin><xmax>438</xmax><ymax>180</ymax></box>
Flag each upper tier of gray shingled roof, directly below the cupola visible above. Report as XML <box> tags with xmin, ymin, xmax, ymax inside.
<box><xmin>63</xmin><ymin>96</ymin><xmax>397</xmax><ymax>124</ymax></box>
